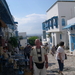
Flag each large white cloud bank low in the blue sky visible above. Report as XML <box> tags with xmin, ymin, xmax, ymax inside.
<box><xmin>15</xmin><ymin>13</ymin><xmax>46</xmax><ymax>34</ymax></box>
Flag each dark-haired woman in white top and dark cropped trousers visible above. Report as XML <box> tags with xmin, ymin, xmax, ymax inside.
<box><xmin>56</xmin><ymin>42</ymin><xmax>65</xmax><ymax>75</ymax></box>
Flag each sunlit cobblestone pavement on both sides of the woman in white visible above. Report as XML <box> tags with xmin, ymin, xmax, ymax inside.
<box><xmin>47</xmin><ymin>50</ymin><xmax>75</xmax><ymax>75</ymax></box>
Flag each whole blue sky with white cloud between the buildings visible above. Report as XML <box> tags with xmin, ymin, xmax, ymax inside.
<box><xmin>6</xmin><ymin>0</ymin><xmax>57</xmax><ymax>35</ymax></box>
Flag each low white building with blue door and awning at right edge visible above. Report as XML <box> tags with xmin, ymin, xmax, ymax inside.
<box><xmin>63</xmin><ymin>17</ymin><xmax>75</xmax><ymax>55</ymax></box>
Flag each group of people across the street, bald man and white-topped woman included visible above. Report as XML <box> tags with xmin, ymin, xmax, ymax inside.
<box><xmin>24</xmin><ymin>39</ymin><xmax>65</xmax><ymax>75</ymax></box>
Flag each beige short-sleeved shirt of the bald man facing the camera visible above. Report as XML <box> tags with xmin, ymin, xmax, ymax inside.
<box><xmin>30</xmin><ymin>46</ymin><xmax>47</xmax><ymax>63</ymax></box>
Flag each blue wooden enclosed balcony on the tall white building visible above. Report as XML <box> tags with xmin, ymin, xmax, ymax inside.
<box><xmin>42</xmin><ymin>16</ymin><xmax>58</xmax><ymax>31</ymax></box>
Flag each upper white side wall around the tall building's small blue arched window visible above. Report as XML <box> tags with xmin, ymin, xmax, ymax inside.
<box><xmin>58</xmin><ymin>2</ymin><xmax>75</xmax><ymax>31</ymax></box>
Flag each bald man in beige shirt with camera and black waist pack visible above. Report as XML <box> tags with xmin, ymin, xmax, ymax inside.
<box><xmin>30</xmin><ymin>39</ymin><xmax>48</xmax><ymax>75</ymax></box>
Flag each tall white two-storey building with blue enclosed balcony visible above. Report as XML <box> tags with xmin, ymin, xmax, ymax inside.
<box><xmin>42</xmin><ymin>0</ymin><xmax>75</xmax><ymax>47</ymax></box>
